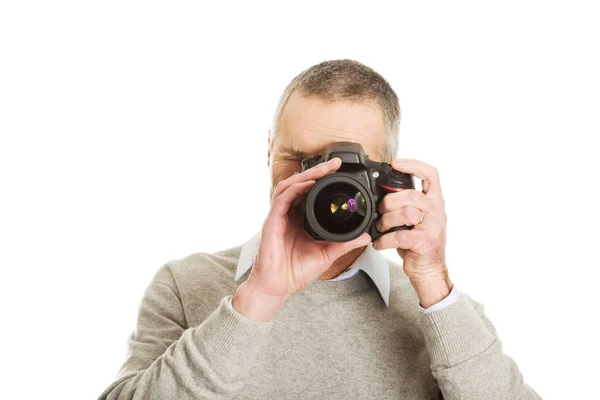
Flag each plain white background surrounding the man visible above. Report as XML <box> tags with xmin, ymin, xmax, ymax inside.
<box><xmin>0</xmin><ymin>1</ymin><xmax>600</xmax><ymax>399</ymax></box>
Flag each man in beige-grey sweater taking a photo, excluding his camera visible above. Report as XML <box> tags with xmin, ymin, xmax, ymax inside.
<box><xmin>100</xmin><ymin>60</ymin><xmax>540</xmax><ymax>400</ymax></box>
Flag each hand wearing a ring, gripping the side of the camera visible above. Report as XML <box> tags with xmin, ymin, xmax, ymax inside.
<box><xmin>373</xmin><ymin>159</ymin><xmax>452</xmax><ymax>308</ymax></box>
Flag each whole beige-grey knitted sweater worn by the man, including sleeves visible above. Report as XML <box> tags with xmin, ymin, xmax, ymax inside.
<box><xmin>100</xmin><ymin>246</ymin><xmax>540</xmax><ymax>400</ymax></box>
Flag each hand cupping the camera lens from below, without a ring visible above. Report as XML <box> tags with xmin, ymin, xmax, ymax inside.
<box><xmin>232</xmin><ymin>158</ymin><xmax>371</xmax><ymax>321</ymax></box>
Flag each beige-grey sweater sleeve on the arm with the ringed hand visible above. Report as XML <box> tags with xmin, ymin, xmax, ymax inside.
<box><xmin>420</xmin><ymin>293</ymin><xmax>541</xmax><ymax>400</ymax></box>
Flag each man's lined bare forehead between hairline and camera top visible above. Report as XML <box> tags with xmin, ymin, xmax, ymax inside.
<box><xmin>276</xmin><ymin>91</ymin><xmax>385</xmax><ymax>158</ymax></box>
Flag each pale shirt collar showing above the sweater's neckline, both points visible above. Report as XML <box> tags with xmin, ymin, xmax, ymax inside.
<box><xmin>235</xmin><ymin>232</ymin><xmax>390</xmax><ymax>307</ymax></box>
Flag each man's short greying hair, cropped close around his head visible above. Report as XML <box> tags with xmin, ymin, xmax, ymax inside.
<box><xmin>271</xmin><ymin>59</ymin><xmax>400</xmax><ymax>162</ymax></box>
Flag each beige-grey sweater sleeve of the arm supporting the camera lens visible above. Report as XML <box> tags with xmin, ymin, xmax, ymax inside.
<box><xmin>99</xmin><ymin>263</ymin><xmax>273</xmax><ymax>400</ymax></box>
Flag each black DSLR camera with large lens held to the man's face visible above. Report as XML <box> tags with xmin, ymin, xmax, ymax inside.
<box><xmin>302</xmin><ymin>142</ymin><xmax>415</xmax><ymax>242</ymax></box>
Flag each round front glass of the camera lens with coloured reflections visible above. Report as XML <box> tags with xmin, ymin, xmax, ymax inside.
<box><xmin>315</xmin><ymin>182</ymin><xmax>367</xmax><ymax>234</ymax></box>
